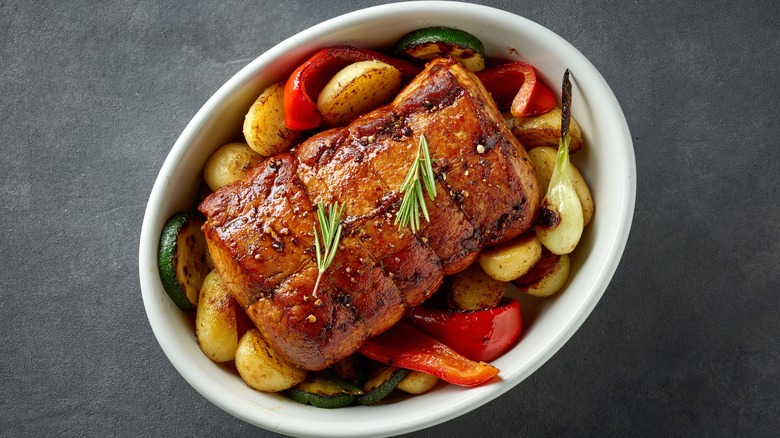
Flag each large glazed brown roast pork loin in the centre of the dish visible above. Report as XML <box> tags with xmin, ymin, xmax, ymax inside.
<box><xmin>200</xmin><ymin>59</ymin><xmax>540</xmax><ymax>370</ymax></box>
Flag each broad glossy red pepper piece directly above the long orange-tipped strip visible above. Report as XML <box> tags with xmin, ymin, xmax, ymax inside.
<box><xmin>406</xmin><ymin>297</ymin><xmax>523</xmax><ymax>362</ymax></box>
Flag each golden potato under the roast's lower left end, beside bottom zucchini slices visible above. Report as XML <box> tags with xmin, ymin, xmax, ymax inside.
<box><xmin>236</xmin><ymin>329</ymin><xmax>308</xmax><ymax>392</ymax></box>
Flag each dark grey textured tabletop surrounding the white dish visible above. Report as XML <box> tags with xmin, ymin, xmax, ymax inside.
<box><xmin>0</xmin><ymin>0</ymin><xmax>780</xmax><ymax>437</ymax></box>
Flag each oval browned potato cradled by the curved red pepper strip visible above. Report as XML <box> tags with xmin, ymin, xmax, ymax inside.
<box><xmin>317</xmin><ymin>60</ymin><xmax>401</xmax><ymax>126</ymax></box>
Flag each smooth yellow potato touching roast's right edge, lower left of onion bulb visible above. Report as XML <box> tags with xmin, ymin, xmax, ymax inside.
<box><xmin>477</xmin><ymin>233</ymin><xmax>542</xmax><ymax>281</ymax></box>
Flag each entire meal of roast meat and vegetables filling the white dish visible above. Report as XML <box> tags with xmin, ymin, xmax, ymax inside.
<box><xmin>159</xmin><ymin>28</ymin><xmax>594</xmax><ymax>408</ymax></box>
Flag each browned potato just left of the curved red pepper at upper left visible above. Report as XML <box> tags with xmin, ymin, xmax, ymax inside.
<box><xmin>244</xmin><ymin>83</ymin><xmax>300</xmax><ymax>157</ymax></box>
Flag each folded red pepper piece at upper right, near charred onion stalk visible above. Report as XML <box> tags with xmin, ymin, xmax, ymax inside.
<box><xmin>477</xmin><ymin>61</ymin><xmax>558</xmax><ymax>117</ymax></box>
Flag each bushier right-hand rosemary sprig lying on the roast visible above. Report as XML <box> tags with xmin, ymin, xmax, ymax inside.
<box><xmin>395</xmin><ymin>135</ymin><xmax>436</xmax><ymax>233</ymax></box>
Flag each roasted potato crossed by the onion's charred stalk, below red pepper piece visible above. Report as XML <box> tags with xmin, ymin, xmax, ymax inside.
<box><xmin>504</xmin><ymin>107</ymin><xmax>583</xmax><ymax>153</ymax></box>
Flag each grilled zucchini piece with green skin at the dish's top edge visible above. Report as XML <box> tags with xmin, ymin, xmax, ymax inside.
<box><xmin>393</xmin><ymin>27</ymin><xmax>486</xmax><ymax>72</ymax></box>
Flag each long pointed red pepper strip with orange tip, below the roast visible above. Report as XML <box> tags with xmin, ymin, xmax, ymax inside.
<box><xmin>359</xmin><ymin>321</ymin><xmax>498</xmax><ymax>386</ymax></box>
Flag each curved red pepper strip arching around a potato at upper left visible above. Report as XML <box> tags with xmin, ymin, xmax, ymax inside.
<box><xmin>284</xmin><ymin>46</ymin><xmax>422</xmax><ymax>131</ymax></box>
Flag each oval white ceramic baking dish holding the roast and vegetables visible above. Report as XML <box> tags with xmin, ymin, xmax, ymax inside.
<box><xmin>139</xmin><ymin>2</ymin><xmax>636</xmax><ymax>437</ymax></box>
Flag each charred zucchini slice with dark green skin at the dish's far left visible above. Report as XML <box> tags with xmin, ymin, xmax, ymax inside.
<box><xmin>157</xmin><ymin>212</ymin><xmax>210</xmax><ymax>310</ymax></box>
